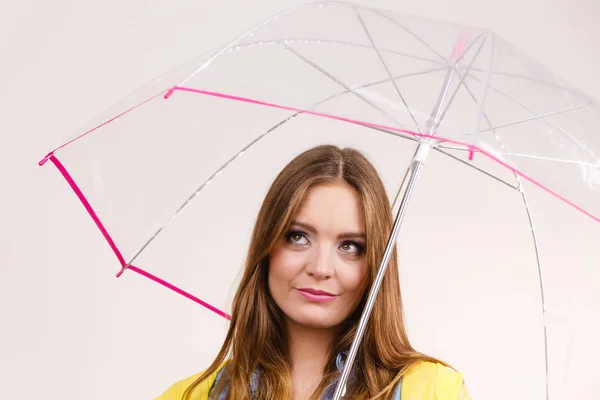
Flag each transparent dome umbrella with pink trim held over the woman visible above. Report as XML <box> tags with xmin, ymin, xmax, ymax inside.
<box><xmin>40</xmin><ymin>2</ymin><xmax>600</xmax><ymax>399</ymax></box>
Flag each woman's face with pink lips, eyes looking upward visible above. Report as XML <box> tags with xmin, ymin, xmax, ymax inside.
<box><xmin>269</xmin><ymin>183</ymin><xmax>367</xmax><ymax>328</ymax></box>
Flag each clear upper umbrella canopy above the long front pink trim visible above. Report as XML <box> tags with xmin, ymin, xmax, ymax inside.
<box><xmin>51</xmin><ymin>2</ymin><xmax>600</xmax><ymax>228</ymax></box>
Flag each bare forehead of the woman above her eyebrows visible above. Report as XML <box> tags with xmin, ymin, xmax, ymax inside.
<box><xmin>295</xmin><ymin>183</ymin><xmax>364</xmax><ymax>231</ymax></box>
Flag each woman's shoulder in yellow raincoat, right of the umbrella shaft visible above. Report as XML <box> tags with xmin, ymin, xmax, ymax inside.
<box><xmin>401</xmin><ymin>361</ymin><xmax>470</xmax><ymax>400</ymax></box>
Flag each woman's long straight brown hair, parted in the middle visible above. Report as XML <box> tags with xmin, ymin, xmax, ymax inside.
<box><xmin>183</xmin><ymin>145</ymin><xmax>446</xmax><ymax>400</ymax></box>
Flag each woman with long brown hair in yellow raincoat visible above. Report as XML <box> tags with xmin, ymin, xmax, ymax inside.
<box><xmin>157</xmin><ymin>146</ymin><xmax>468</xmax><ymax>400</ymax></box>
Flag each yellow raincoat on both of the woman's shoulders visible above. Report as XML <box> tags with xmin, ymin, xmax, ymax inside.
<box><xmin>156</xmin><ymin>362</ymin><xmax>471</xmax><ymax>400</ymax></box>
